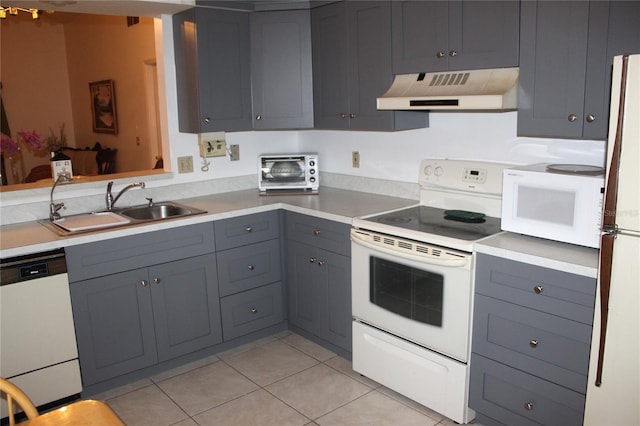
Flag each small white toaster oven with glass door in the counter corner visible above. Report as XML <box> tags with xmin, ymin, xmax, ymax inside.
<box><xmin>258</xmin><ymin>153</ymin><xmax>320</xmax><ymax>193</ymax></box>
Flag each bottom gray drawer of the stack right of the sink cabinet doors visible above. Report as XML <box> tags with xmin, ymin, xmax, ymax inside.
<box><xmin>220</xmin><ymin>282</ymin><xmax>284</xmax><ymax>341</ymax></box>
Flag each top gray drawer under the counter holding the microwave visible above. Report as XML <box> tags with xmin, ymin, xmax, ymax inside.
<box><xmin>476</xmin><ymin>253</ymin><xmax>596</xmax><ymax>324</ymax></box>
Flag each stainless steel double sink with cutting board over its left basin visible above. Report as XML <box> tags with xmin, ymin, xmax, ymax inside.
<box><xmin>46</xmin><ymin>201</ymin><xmax>206</xmax><ymax>235</ymax></box>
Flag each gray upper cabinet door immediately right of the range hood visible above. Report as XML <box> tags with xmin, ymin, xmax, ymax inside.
<box><xmin>518</xmin><ymin>1</ymin><xmax>589</xmax><ymax>138</ymax></box>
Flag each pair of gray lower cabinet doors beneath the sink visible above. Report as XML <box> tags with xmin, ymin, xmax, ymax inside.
<box><xmin>70</xmin><ymin>254</ymin><xmax>222</xmax><ymax>386</ymax></box>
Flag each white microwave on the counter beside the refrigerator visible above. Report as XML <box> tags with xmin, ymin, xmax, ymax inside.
<box><xmin>501</xmin><ymin>164</ymin><xmax>604</xmax><ymax>248</ymax></box>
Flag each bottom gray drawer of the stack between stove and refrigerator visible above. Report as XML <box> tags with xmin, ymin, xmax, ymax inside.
<box><xmin>469</xmin><ymin>354</ymin><xmax>585</xmax><ymax>426</ymax></box>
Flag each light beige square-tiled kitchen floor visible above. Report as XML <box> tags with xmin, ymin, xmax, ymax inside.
<box><xmin>98</xmin><ymin>332</ymin><xmax>455</xmax><ymax>426</ymax></box>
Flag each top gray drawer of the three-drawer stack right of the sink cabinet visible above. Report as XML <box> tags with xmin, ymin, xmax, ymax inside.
<box><xmin>214</xmin><ymin>210</ymin><xmax>280</xmax><ymax>250</ymax></box>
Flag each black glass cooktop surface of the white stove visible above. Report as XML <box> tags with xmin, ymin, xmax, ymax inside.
<box><xmin>365</xmin><ymin>206</ymin><xmax>500</xmax><ymax>241</ymax></box>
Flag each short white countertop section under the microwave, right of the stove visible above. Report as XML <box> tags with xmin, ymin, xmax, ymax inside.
<box><xmin>475</xmin><ymin>232</ymin><xmax>599</xmax><ymax>278</ymax></box>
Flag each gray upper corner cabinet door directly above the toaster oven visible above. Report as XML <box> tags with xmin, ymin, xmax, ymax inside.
<box><xmin>250</xmin><ymin>10</ymin><xmax>313</xmax><ymax>130</ymax></box>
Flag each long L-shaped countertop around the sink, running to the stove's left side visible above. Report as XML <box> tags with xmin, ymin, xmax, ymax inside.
<box><xmin>0</xmin><ymin>187</ymin><xmax>417</xmax><ymax>259</ymax></box>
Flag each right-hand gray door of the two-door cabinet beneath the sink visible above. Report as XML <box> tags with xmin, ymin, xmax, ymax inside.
<box><xmin>149</xmin><ymin>254</ymin><xmax>222</xmax><ymax>362</ymax></box>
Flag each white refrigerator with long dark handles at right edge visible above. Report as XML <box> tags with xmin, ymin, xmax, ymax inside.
<box><xmin>584</xmin><ymin>55</ymin><xmax>640</xmax><ymax>426</ymax></box>
